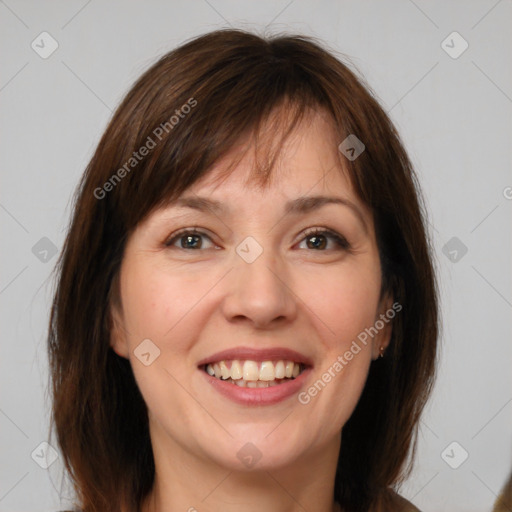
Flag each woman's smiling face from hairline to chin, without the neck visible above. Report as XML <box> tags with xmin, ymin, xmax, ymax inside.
<box><xmin>112</xmin><ymin>113</ymin><xmax>390</xmax><ymax>470</ymax></box>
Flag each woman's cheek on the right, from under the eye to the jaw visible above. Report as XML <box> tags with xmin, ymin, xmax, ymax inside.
<box><xmin>299</xmin><ymin>263</ymin><xmax>380</xmax><ymax>422</ymax></box>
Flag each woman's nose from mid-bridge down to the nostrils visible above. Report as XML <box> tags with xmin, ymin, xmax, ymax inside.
<box><xmin>222</xmin><ymin>250</ymin><xmax>297</xmax><ymax>329</ymax></box>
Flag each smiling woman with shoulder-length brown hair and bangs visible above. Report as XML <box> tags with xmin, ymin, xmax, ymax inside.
<box><xmin>49</xmin><ymin>30</ymin><xmax>437</xmax><ymax>512</ymax></box>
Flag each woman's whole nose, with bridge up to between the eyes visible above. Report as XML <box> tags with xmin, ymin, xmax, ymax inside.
<box><xmin>224</xmin><ymin>237</ymin><xmax>296</xmax><ymax>327</ymax></box>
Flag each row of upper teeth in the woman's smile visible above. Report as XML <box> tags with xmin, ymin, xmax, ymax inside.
<box><xmin>206</xmin><ymin>359</ymin><xmax>301</xmax><ymax>381</ymax></box>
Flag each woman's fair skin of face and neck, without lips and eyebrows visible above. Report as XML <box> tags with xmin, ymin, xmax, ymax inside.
<box><xmin>111</xmin><ymin>112</ymin><xmax>392</xmax><ymax>512</ymax></box>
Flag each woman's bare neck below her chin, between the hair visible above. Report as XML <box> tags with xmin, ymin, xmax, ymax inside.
<box><xmin>141</xmin><ymin>424</ymin><xmax>340</xmax><ymax>512</ymax></box>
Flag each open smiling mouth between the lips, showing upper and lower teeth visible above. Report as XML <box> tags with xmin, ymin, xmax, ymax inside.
<box><xmin>201</xmin><ymin>359</ymin><xmax>306</xmax><ymax>388</ymax></box>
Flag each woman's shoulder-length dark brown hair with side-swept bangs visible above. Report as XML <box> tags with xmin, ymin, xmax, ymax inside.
<box><xmin>48</xmin><ymin>30</ymin><xmax>438</xmax><ymax>512</ymax></box>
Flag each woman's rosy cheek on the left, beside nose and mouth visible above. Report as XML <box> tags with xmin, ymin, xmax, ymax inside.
<box><xmin>121</xmin><ymin>262</ymin><xmax>228</xmax><ymax>388</ymax></box>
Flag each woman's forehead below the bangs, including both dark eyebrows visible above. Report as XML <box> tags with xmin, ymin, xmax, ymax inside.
<box><xmin>148</xmin><ymin>110</ymin><xmax>374</xmax><ymax>240</ymax></box>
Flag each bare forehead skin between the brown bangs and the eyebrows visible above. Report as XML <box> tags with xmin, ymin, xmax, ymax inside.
<box><xmin>183</xmin><ymin>111</ymin><xmax>361</xmax><ymax>207</ymax></box>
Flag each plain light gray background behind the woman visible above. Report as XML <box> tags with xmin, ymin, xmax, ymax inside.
<box><xmin>0</xmin><ymin>0</ymin><xmax>512</xmax><ymax>512</ymax></box>
